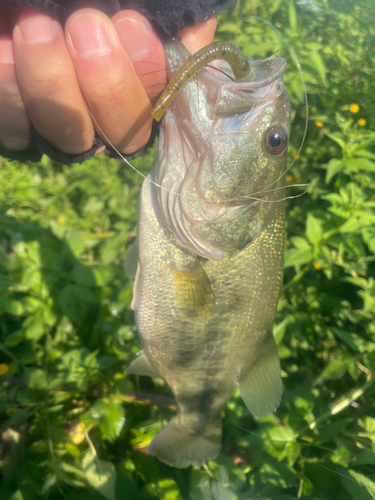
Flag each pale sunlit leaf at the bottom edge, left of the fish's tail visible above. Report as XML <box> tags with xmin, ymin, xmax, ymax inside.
<box><xmin>82</xmin><ymin>451</ymin><xmax>117</xmax><ymax>500</ymax></box>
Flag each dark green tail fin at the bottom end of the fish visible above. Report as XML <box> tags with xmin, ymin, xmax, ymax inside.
<box><xmin>148</xmin><ymin>415</ymin><xmax>221</xmax><ymax>469</ymax></box>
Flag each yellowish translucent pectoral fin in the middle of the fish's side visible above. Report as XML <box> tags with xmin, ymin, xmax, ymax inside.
<box><xmin>172</xmin><ymin>260</ymin><xmax>215</xmax><ymax>319</ymax></box>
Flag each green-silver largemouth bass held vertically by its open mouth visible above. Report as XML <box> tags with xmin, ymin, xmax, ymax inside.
<box><xmin>125</xmin><ymin>41</ymin><xmax>290</xmax><ymax>468</ymax></box>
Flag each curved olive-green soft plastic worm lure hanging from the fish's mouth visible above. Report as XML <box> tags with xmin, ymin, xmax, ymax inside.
<box><xmin>151</xmin><ymin>42</ymin><xmax>252</xmax><ymax>121</ymax></box>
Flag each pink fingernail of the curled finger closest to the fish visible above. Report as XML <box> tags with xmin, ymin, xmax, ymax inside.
<box><xmin>116</xmin><ymin>17</ymin><xmax>151</xmax><ymax>61</ymax></box>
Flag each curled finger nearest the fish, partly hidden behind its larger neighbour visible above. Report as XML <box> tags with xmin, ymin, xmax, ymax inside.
<box><xmin>112</xmin><ymin>10</ymin><xmax>168</xmax><ymax>102</ymax></box>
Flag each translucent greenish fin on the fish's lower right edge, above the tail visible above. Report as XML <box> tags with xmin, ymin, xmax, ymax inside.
<box><xmin>238</xmin><ymin>336</ymin><xmax>282</xmax><ymax>417</ymax></box>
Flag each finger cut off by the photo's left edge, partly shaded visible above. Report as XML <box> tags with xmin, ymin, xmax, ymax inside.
<box><xmin>0</xmin><ymin>36</ymin><xmax>30</xmax><ymax>152</ymax></box>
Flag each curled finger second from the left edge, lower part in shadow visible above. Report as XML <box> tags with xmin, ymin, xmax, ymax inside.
<box><xmin>13</xmin><ymin>11</ymin><xmax>94</xmax><ymax>154</ymax></box>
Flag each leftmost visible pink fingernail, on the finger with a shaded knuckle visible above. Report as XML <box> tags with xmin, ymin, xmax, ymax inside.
<box><xmin>18</xmin><ymin>14</ymin><xmax>61</xmax><ymax>43</ymax></box>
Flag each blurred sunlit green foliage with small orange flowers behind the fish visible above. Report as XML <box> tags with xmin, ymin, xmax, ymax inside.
<box><xmin>0</xmin><ymin>0</ymin><xmax>375</xmax><ymax>500</ymax></box>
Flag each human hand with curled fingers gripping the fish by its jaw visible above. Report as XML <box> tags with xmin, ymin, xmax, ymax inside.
<box><xmin>0</xmin><ymin>3</ymin><xmax>216</xmax><ymax>154</ymax></box>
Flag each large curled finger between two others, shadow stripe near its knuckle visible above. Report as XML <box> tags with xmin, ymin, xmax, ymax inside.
<box><xmin>65</xmin><ymin>8</ymin><xmax>152</xmax><ymax>153</ymax></box>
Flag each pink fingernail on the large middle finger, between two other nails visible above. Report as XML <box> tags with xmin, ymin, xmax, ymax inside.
<box><xmin>69</xmin><ymin>14</ymin><xmax>111</xmax><ymax>57</ymax></box>
